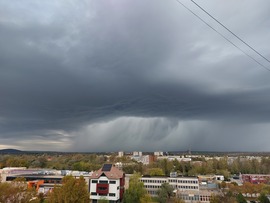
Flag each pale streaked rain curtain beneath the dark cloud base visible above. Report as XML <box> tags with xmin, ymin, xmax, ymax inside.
<box><xmin>70</xmin><ymin>117</ymin><xmax>269</xmax><ymax>151</ymax></box>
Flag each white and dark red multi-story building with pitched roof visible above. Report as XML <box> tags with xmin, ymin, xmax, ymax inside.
<box><xmin>89</xmin><ymin>164</ymin><xmax>125</xmax><ymax>203</ymax></box>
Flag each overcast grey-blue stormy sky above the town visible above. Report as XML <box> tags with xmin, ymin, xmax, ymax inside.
<box><xmin>0</xmin><ymin>0</ymin><xmax>270</xmax><ymax>152</ymax></box>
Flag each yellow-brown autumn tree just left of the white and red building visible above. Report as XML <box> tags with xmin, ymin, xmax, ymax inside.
<box><xmin>48</xmin><ymin>176</ymin><xmax>89</xmax><ymax>203</ymax></box>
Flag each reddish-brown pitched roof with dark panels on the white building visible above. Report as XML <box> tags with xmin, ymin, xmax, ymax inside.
<box><xmin>90</xmin><ymin>164</ymin><xmax>124</xmax><ymax>179</ymax></box>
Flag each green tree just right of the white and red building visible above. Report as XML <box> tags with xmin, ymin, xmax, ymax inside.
<box><xmin>123</xmin><ymin>173</ymin><xmax>147</xmax><ymax>203</ymax></box>
